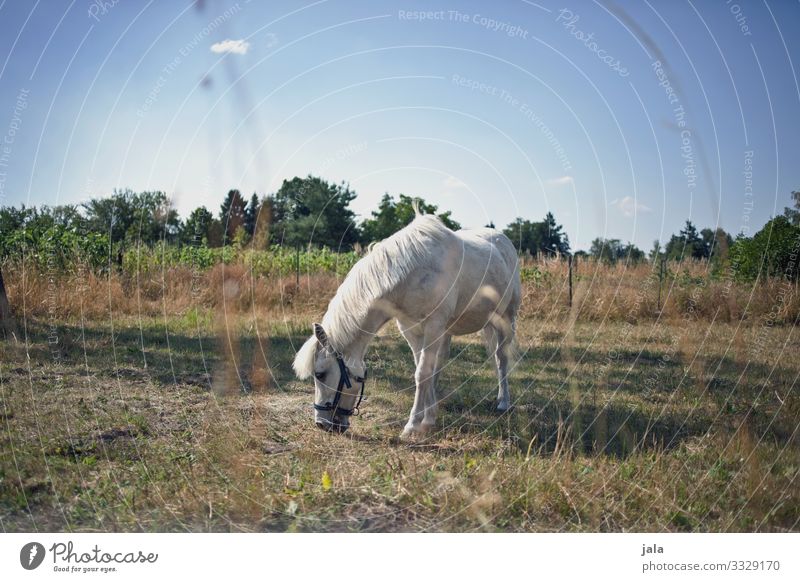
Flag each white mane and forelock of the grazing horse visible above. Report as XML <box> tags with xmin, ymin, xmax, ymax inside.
<box><xmin>294</xmin><ymin>212</ymin><xmax>453</xmax><ymax>378</ymax></box>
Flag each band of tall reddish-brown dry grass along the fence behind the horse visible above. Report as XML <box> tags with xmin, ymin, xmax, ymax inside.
<box><xmin>4</xmin><ymin>261</ymin><xmax>800</xmax><ymax>325</ymax></box>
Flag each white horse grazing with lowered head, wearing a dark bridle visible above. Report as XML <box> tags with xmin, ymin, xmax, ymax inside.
<box><xmin>293</xmin><ymin>206</ymin><xmax>520</xmax><ymax>436</ymax></box>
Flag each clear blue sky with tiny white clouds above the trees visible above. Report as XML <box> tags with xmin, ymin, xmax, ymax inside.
<box><xmin>0</xmin><ymin>0</ymin><xmax>800</xmax><ymax>250</ymax></box>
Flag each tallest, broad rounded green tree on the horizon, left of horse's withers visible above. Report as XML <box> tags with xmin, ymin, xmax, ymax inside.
<box><xmin>268</xmin><ymin>175</ymin><xmax>359</xmax><ymax>250</ymax></box>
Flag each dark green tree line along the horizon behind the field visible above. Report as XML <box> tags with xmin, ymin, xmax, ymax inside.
<box><xmin>0</xmin><ymin>175</ymin><xmax>800</xmax><ymax>278</ymax></box>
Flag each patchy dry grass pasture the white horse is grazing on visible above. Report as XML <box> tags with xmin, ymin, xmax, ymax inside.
<box><xmin>0</xmin><ymin>273</ymin><xmax>800</xmax><ymax>531</ymax></box>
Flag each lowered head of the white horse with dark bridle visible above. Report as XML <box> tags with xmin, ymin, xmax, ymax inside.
<box><xmin>294</xmin><ymin>323</ymin><xmax>366</xmax><ymax>432</ymax></box>
